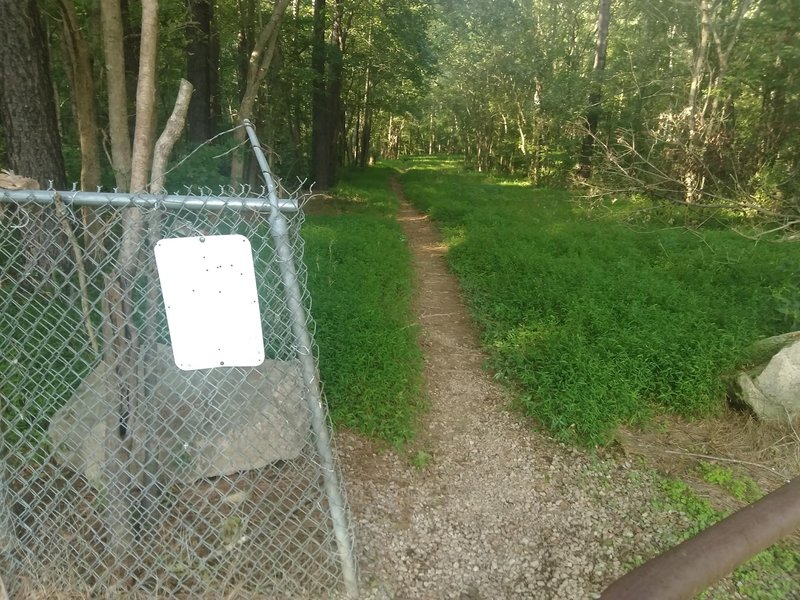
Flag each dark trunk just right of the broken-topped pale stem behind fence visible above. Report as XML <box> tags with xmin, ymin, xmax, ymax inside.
<box><xmin>186</xmin><ymin>0</ymin><xmax>214</xmax><ymax>142</ymax></box>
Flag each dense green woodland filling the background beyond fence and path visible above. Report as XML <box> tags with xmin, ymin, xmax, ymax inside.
<box><xmin>0</xmin><ymin>0</ymin><xmax>800</xmax><ymax>232</ymax></box>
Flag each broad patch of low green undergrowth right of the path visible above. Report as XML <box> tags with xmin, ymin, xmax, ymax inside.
<box><xmin>401</xmin><ymin>159</ymin><xmax>800</xmax><ymax>445</ymax></box>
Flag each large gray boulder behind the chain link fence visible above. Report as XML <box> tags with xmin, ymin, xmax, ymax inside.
<box><xmin>48</xmin><ymin>346</ymin><xmax>310</xmax><ymax>489</ymax></box>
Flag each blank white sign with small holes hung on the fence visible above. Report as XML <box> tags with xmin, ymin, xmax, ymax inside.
<box><xmin>155</xmin><ymin>235</ymin><xmax>264</xmax><ymax>371</ymax></box>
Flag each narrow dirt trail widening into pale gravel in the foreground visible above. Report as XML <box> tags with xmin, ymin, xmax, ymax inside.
<box><xmin>337</xmin><ymin>183</ymin><xmax>674</xmax><ymax>600</ymax></box>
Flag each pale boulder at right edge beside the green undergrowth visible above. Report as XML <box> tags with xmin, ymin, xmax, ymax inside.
<box><xmin>737</xmin><ymin>341</ymin><xmax>800</xmax><ymax>421</ymax></box>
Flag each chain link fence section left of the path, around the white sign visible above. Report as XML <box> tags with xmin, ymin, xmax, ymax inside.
<box><xmin>0</xmin><ymin>145</ymin><xmax>356</xmax><ymax>598</ymax></box>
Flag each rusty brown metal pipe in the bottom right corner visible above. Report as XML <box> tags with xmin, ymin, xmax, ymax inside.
<box><xmin>601</xmin><ymin>477</ymin><xmax>800</xmax><ymax>600</ymax></box>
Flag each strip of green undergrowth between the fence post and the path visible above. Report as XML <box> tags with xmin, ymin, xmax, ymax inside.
<box><xmin>302</xmin><ymin>169</ymin><xmax>422</xmax><ymax>446</ymax></box>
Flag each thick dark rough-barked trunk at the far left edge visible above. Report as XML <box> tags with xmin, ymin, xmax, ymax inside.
<box><xmin>0</xmin><ymin>0</ymin><xmax>66</xmax><ymax>189</ymax></box>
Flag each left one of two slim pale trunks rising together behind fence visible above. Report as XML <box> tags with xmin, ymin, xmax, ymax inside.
<box><xmin>100</xmin><ymin>0</ymin><xmax>131</xmax><ymax>191</ymax></box>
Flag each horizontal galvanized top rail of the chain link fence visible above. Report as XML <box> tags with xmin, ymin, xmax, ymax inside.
<box><xmin>0</xmin><ymin>187</ymin><xmax>300</xmax><ymax>213</ymax></box>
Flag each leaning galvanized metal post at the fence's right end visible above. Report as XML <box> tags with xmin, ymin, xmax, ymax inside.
<box><xmin>244</xmin><ymin>120</ymin><xmax>358</xmax><ymax>598</ymax></box>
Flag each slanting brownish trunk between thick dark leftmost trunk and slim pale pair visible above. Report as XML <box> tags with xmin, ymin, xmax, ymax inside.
<box><xmin>59</xmin><ymin>0</ymin><xmax>101</xmax><ymax>191</ymax></box>
